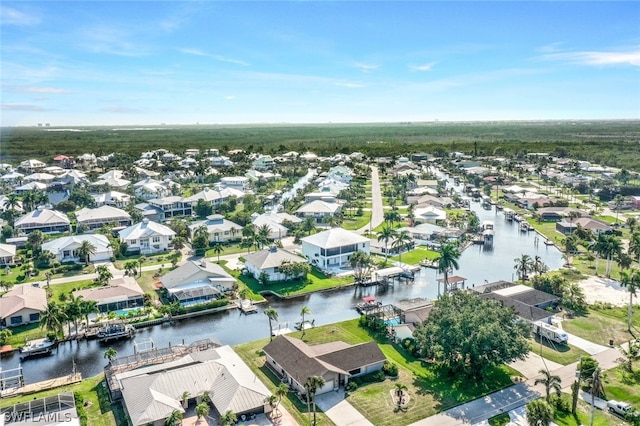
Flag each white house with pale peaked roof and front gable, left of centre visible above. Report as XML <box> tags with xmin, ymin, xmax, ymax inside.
<box><xmin>119</xmin><ymin>218</ymin><xmax>176</xmax><ymax>254</ymax></box>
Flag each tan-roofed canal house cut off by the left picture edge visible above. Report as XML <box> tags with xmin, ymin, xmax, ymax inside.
<box><xmin>0</xmin><ymin>284</ymin><xmax>47</xmax><ymax>327</ymax></box>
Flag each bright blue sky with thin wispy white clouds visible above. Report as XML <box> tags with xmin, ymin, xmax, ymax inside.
<box><xmin>0</xmin><ymin>0</ymin><xmax>640</xmax><ymax>126</ymax></box>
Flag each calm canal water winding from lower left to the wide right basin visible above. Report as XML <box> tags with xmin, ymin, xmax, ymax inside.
<box><xmin>0</xmin><ymin>178</ymin><xmax>563</xmax><ymax>383</ymax></box>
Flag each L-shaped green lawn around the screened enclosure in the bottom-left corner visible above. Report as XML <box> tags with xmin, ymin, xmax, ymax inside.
<box><xmin>2</xmin><ymin>374</ymin><xmax>121</xmax><ymax>426</ymax></box>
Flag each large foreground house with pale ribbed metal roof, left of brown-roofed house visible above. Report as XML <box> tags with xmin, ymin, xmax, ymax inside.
<box><xmin>115</xmin><ymin>346</ymin><xmax>271</xmax><ymax>426</ymax></box>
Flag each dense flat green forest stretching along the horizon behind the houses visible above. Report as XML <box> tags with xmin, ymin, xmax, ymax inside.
<box><xmin>0</xmin><ymin>120</ymin><xmax>640</xmax><ymax>171</ymax></box>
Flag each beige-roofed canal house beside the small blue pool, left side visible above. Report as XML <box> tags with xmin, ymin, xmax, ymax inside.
<box><xmin>73</xmin><ymin>276</ymin><xmax>144</xmax><ymax>314</ymax></box>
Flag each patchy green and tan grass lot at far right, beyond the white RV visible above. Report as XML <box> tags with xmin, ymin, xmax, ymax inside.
<box><xmin>562</xmin><ymin>305</ymin><xmax>640</xmax><ymax>346</ymax></box>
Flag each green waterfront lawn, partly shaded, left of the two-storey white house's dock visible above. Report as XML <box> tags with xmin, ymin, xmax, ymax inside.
<box><xmin>234</xmin><ymin>267</ymin><xmax>353</xmax><ymax>296</ymax></box>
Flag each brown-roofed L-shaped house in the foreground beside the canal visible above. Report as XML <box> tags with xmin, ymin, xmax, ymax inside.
<box><xmin>263</xmin><ymin>335</ymin><xmax>386</xmax><ymax>395</ymax></box>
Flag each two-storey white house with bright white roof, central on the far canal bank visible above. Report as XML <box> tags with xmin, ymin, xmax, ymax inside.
<box><xmin>302</xmin><ymin>228</ymin><xmax>370</xmax><ymax>269</ymax></box>
